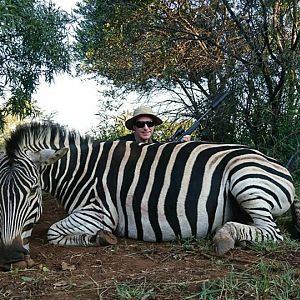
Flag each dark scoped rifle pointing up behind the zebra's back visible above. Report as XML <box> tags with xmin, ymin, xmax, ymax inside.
<box><xmin>168</xmin><ymin>92</ymin><xmax>229</xmax><ymax>142</ymax></box>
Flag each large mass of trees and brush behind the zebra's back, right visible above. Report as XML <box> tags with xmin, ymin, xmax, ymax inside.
<box><xmin>76</xmin><ymin>0</ymin><xmax>300</xmax><ymax>162</ymax></box>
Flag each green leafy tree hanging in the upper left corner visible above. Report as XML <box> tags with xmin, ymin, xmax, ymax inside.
<box><xmin>0</xmin><ymin>0</ymin><xmax>71</xmax><ymax>128</ymax></box>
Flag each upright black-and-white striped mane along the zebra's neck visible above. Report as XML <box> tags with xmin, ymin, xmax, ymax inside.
<box><xmin>5</xmin><ymin>122</ymin><xmax>93</xmax><ymax>160</ymax></box>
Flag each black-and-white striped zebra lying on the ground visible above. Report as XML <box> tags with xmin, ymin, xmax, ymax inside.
<box><xmin>0</xmin><ymin>123</ymin><xmax>300</xmax><ymax>266</ymax></box>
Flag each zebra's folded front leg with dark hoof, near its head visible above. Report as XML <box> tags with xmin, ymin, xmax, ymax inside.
<box><xmin>47</xmin><ymin>204</ymin><xmax>117</xmax><ymax>246</ymax></box>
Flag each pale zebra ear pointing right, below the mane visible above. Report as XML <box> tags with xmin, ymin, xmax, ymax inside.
<box><xmin>27</xmin><ymin>147</ymin><xmax>69</xmax><ymax>165</ymax></box>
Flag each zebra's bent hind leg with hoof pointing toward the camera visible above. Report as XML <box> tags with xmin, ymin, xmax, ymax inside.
<box><xmin>213</xmin><ymin>200</ymin><xmax>283</xmax><ymax>255</ymax></box>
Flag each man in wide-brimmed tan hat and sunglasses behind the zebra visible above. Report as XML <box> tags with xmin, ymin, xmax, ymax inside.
<box><xmin>118</xmin><ymin>105</ymin><xmax>191</xmax><ymax>143</ymax></box>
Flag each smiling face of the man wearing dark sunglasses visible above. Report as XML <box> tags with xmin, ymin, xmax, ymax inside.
<box><xmin>133</xmin><ymin>115</ymin><xmax>154</xmax><ymax>143</ymax></box>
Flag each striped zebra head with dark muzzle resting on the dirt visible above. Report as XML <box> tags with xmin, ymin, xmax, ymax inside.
<box><xmin>0</xmin><ymin>134</ymin><xmax>68</xmax><ymax>269</ymax></box>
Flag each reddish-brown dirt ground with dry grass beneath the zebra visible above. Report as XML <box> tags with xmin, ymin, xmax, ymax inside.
<box><xmin>0</xmin><ymin>197</ymin><xmax>300</xmax><ymax>300</ymax></box>
